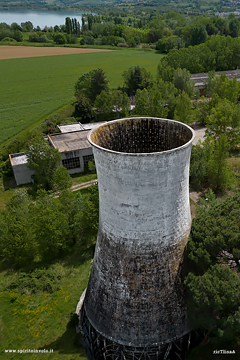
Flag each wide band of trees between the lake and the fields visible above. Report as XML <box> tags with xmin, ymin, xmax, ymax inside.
<box><xmin>0</xmin><ymin>11</ymin><xmax>240</xmax><ymax>47</ymax></box>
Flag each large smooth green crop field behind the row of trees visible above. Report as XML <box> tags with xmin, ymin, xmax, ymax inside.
<box><xmin>0</xmin><ymin>49</ymin><xmax>162</xmax><ymax>147</ymax></box>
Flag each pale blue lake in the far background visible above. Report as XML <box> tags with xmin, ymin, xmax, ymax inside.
<box><xmin>0</xmin><ymin>10</ymin><xmax>96</xmax><ymax>29</ymax></box>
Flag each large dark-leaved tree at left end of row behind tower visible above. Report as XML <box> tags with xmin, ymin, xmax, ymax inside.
<box><xmin>75</xmin><ymin>69</ymin><xmax>108</xmax><ymax>103</ymax></box>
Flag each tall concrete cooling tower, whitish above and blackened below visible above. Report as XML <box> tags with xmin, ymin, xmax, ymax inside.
<box><xmin>80</xmin><ymin>117</ymin><xmax>194</xmax><ymax>360</ymax></box>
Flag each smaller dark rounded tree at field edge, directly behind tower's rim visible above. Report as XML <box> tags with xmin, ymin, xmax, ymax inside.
<box><xmin>122</xmin><ymin>65</ymin><xmax>152</xmax><ymax>96</ymax></box>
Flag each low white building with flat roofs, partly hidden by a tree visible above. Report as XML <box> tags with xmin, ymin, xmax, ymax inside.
<box><xmin>9</xmin><ymin>122</ymin><xmax>103</xmax><ymax>185</ymax></box>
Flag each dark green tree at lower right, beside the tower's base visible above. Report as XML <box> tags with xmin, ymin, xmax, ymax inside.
<box><xmin>185</xmin><ymin>264</ymin><xmax>240</xmax><ymax>340</ymax></box>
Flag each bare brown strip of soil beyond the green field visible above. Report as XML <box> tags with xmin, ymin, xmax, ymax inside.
<box><xmin>0</xmin><ymin>45</ymin><xmax>113</xmax><ymax>60</ymax></box>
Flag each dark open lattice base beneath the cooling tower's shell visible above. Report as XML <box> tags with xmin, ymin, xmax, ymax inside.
<box><xmin>79</xmin><ymin>306</ymin><xmax>204</xmax><ymax>360</ymax></box>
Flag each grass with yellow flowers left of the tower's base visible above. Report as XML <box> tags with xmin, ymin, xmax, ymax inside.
<box><xmin>0</xmin><ymin>237</ymin><xmax>95</xmax><ymax>360</ymax></box>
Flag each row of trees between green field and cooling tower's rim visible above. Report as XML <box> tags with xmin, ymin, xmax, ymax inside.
<box><xmin>74</xmin><ymin>66</ymin><xmax>194</xmax><ymax>122</ymax></box>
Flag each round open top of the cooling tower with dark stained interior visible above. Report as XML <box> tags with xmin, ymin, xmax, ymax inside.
<box><xmin>88</xmin><ymin>117</ymin><xmax>194</xmax><ymax>155</ymax></box>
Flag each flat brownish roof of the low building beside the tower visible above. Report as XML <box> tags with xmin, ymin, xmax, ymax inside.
<box><xmin>49</xmin><ymin>130</ymin><xmax>91</xmax><ymax>152</ymax></box>
